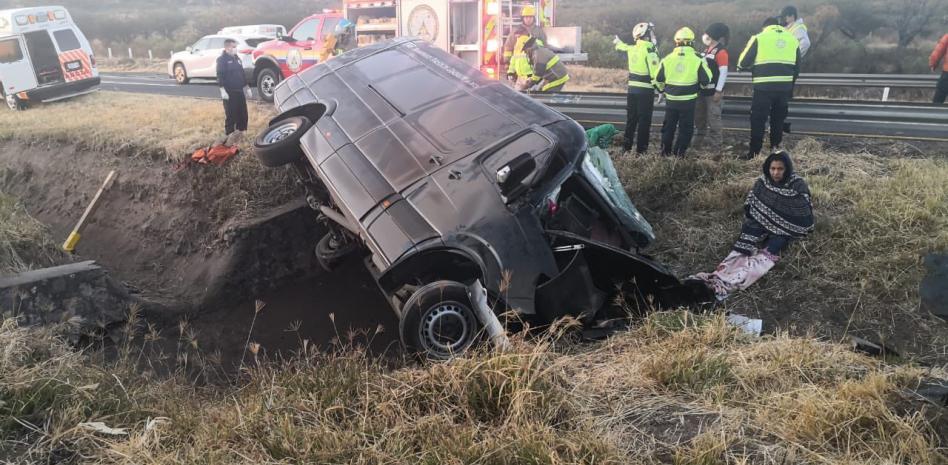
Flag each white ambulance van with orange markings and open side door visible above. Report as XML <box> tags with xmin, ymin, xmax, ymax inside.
<box><xmin>0</xmin><ymin>6</ymin><xmax>99</xmax><ymax>110</ymax></box>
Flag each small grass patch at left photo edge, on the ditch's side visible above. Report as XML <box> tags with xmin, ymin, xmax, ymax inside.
<box><xmin>0</xmin><ymin>192</ymin><xmax>63</xmax><ymax>276</ymax></box>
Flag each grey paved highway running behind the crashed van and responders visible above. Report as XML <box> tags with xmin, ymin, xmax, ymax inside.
<box><xmin>102</xmin><ymin>73</ymin><xmax>948</xmax><ymax>143</ymax></box>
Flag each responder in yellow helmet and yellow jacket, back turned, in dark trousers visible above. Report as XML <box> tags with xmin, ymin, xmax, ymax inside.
<box><xmin>655</xmin><ymin>27</ymin><xmax>711</xmax><ymax>157</ymax></box>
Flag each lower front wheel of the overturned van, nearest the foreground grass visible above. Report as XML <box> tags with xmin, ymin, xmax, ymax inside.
<box><xmin>398</xmin><ymin>281</ymin><xmax>481</xmax><ymax>360</ymax></box>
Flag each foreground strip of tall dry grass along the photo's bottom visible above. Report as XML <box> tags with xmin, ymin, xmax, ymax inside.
<box><xmin>0</xmin><ymin>313</ymin><xmax>945</xmax><ymax>465</ymax></box>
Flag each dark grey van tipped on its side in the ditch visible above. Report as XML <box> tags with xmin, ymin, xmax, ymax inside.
<box><xmin>255</xmin><ymin>39</ymin><xmax>708</xmax><ymax>358</ymax></box>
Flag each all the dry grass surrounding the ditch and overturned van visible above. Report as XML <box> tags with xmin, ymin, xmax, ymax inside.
<box><xmin>0</xmin><ymin>94</ymin><xmax>948</xmax><ymax>465</ymax></box>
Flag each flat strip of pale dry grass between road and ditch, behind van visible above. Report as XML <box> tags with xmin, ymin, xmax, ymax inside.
<box><xmin>0</xmin><ymin>92</ymin><xmax>273</xmax><ymax>161</ymax></box>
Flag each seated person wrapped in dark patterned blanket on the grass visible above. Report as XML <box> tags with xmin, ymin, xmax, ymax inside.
<box><xmin>688</xmin><ymin>151</ymin><xmax>813</xmax><ymax>301</ymax></box>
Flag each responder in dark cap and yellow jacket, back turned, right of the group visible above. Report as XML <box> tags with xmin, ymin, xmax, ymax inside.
<box><xmin>737</xmin><ymin>18</ymin><xmax>800</xmax><ymax>160</ymax></box>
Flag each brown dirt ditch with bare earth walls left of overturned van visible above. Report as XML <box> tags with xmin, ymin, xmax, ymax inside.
<box><xmin>0</xmin><ymin>143</ymin><xmax>397</xmax><ymax>359</ymax></box>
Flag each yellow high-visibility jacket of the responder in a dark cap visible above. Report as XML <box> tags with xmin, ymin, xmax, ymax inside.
<box><xmin>745</xmin><ymin>26</ymin><xmax>800</xmax><ymax>84</ymax></box>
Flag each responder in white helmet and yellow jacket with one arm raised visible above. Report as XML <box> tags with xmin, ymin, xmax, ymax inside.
<box><xmin>612</xmin><ymin>23</ymin><xmax>659</xmax><ymax>155</ymax></box>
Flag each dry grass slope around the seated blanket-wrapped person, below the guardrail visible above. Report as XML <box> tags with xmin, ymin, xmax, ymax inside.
<box><xmin>617</xmin><ymin>139</ymin><xmax>948</xmax><ymax>363</ymax></box>
